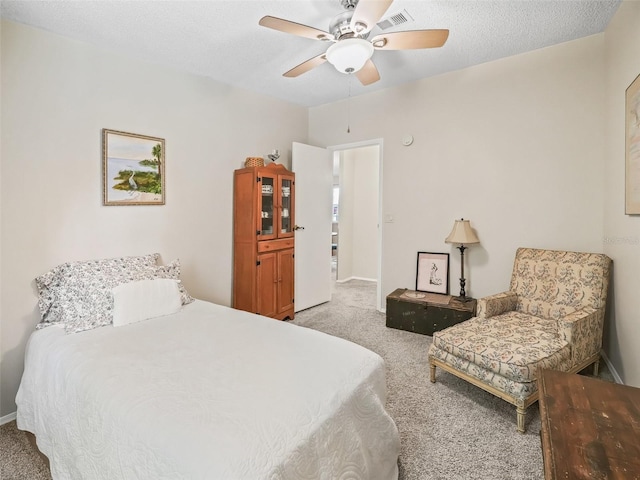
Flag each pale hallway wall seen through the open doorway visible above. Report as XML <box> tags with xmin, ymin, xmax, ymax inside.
<box><xmin>337</xmin><ymin>145</ymin><xmax>380</xmax><ymax>281</ymax></box>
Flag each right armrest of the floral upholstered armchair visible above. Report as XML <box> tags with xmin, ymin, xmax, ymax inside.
<box><xmin>558</xmin><ymin>307</ymin><xmax>604</xmax><ymax>365</ymax></box>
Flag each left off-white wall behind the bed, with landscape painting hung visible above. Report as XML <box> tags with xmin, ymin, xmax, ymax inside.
<box><xmin>0</xmin><ymin>21</ymin><xmax>308</xmax><ymax>416</ymax></box>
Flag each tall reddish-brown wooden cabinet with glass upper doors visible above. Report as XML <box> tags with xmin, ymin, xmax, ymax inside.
<box><xmin>233</xmin><ymin>163</ymin><xmax>295</xmax><ymax>320</ymax></box>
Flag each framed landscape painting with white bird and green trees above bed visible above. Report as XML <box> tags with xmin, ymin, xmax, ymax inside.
<box><xmin>102</xmin><ymin>128</ymin><xmax>165</xmax><ymax>205</ymax></box>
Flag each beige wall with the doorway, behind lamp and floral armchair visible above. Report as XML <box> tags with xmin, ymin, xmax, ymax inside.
<box><xmin>309</xmin><ymin>34</ymin><xmax>604</xmax><ymax>312</ymax></box>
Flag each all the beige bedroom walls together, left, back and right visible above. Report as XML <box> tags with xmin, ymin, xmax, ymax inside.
<box><xmin>0</xmin><ymin>1</ymin><xmax>640</xmax><ymax>416</ymax></box>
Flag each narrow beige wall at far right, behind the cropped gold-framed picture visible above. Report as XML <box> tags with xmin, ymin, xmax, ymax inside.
<box><xmin>604</xmin><ymin>1</ymin><xmax>640</xmax><ymax>387</ymax></box>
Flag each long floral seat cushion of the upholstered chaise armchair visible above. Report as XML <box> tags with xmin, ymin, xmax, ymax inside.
<box><xmin>433</xmin><ymin>312</ymin><xmax>571</xmax><ymax>382</ymax></box>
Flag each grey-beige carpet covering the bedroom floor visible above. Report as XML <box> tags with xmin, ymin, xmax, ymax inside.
<box><xmin>0</xmin><ymin>280</ymin><xmax>612</xmax><ymax>480</ymax></box>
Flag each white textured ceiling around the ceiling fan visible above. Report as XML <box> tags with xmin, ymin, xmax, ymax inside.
<box><xmin>0</xmin><ymin>0</ymin><xmax>620</xmax><ymax>106</ymax></box>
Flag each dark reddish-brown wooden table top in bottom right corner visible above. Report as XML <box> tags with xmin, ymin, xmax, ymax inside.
<box><xmin>538</xmin><ymin>370</ymin><xmax>640</xmax><ymax>480</ymax></box>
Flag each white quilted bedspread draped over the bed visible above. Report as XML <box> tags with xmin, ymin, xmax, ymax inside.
<box><xmin>16</xmin><ymin>301</ymin><xmax>400</xmax><ymax>480</ymax></box>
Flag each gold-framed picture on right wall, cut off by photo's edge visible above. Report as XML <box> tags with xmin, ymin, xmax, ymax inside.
<box><xmin>624</xmin><ymin>75</ymin><xmax>640</xmax><ymax>215</ymax></box>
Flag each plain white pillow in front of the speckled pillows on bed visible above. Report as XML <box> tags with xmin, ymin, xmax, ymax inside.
<box><xmin>111</xmin><ymin>278</ymin><xmax>182</xmax><ymax>327</ymax></box>
